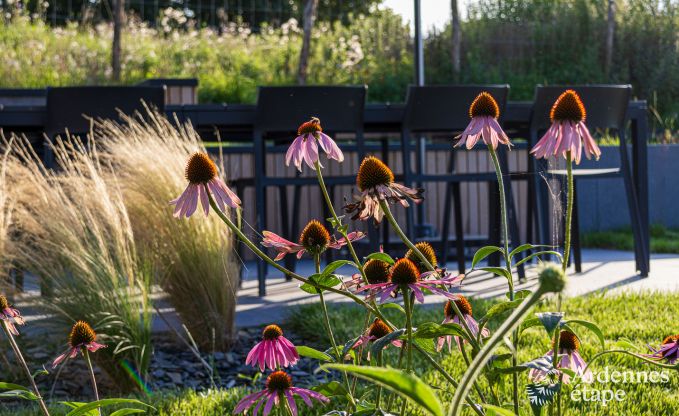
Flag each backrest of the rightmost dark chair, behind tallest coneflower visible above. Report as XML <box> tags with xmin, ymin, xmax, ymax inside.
<box><xmin>530</xmin><ymin>85</ymin><xmax>632</xmax><ymax>131</ymax></box>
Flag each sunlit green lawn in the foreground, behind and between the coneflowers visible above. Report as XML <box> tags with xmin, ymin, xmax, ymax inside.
<box><xmin>0</xmin><ymin>293</ymin><xmax>679</xmax><ymax>416</ymax></box>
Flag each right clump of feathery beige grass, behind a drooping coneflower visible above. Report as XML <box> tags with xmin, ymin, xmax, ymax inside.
<box><xmin>95</xmin><ymin>113</ymin><xmax>239</xmax><ymax>350</ymax></box>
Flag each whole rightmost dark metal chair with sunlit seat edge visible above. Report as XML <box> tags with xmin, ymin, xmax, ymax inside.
<box><xmin>527</xmin><ymin>85</ymin><xmax>649</xmax><ymax>276</ymax></box>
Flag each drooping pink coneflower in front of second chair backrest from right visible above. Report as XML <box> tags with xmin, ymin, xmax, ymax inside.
<box><xmin>455</xmin><ymin>91</ymin><xmax>512</xmax><ymax>149</ymax></box>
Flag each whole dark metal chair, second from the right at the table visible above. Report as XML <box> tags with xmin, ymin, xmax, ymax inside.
<box><xmin>401</xmin><ymin>85</ymin><xmax>523</xmax><ymax>277</ymax></box>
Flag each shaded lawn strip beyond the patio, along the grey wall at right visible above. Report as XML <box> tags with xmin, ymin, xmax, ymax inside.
<box><xmin>582</xmin><ymin>224</ymin><xmax>679</xmax><ymax>254</ymax></box>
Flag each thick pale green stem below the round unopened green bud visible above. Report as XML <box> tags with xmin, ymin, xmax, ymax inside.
<box><xmin>448</xmin><ymin>287</ymin><xmax>544</xmax><ymax>416</ymax></box>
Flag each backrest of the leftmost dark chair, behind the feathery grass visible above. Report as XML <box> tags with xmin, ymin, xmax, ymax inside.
<box><xmin>45</xmin><ymin>86</ymin><xmax>165</xmax><ymax>136</ymax></box>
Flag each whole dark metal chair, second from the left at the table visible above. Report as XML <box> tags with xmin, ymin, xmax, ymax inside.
<box><xmin>254</xmin><ymin>86</ymin><xmax>366</xmax><ymax>296</ymax></box>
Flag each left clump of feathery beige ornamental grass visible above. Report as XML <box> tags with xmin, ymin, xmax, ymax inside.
<box><xmin>6</xmin><ymin>138</ymin><xmax>152</xmax><ymax>390</ymax></box>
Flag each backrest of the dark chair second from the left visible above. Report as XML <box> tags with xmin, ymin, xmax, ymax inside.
<box><xmin>254</xmin><ymin>85</ymin><xmax>367</xmax><ymax>134</ymax></box>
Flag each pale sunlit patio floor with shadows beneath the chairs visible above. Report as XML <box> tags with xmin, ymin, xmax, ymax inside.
<box><xmin>236</xmin><ymin>250</ymin><xmax>679</xmax><ymax>326</ymax></box>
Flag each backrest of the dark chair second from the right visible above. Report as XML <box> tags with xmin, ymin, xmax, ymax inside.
<box><xmin>403</xmin><ymin>84</ymin><xmax>509</xmax><ymax>132</ymax></box>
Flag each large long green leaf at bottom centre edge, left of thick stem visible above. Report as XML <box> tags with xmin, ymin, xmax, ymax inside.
<box><xmin>323</xmin><ymin>364</ymin><xmax>443</xmax><ymax>416</ymax></box>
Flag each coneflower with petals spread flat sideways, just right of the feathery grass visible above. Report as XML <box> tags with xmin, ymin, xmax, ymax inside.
<box><xmin>262</xmin><ymin>220</ymin><xmax>365</xmax><ymax>261</ymax></box>
